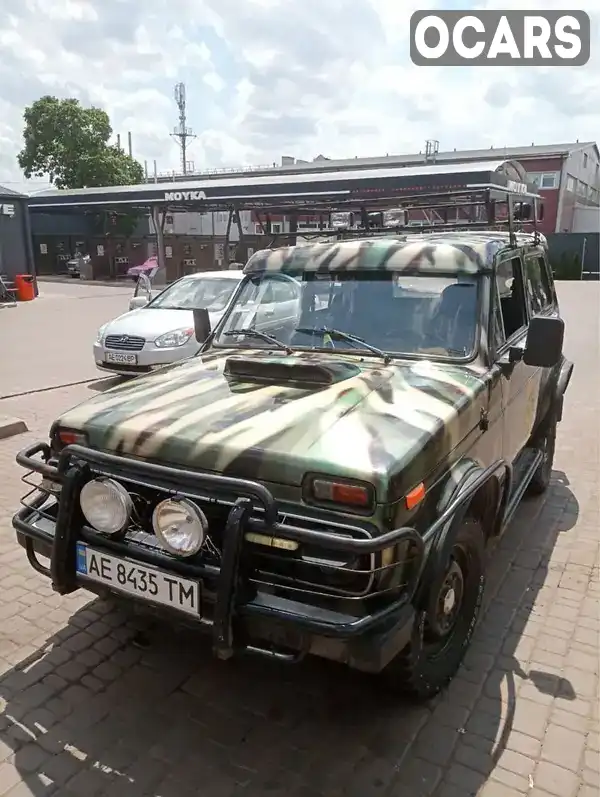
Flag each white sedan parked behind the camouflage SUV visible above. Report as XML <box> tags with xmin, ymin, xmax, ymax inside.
<box><xmin>94</xmin><ymin>271</ymin><xmax>243</xmax><ymax>376</ymax></box>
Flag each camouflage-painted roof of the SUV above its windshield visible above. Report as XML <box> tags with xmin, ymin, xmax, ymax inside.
<box><xmin>244</xmin><ymin>231</ymin><xmax>534</xmax><ymax>274</ymax></box>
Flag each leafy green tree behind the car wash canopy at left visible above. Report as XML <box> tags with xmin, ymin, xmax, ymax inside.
<box><xmin>18</xmin><ymin>96</ymin><xmax>144</xmax><ymax>188</ymax></box>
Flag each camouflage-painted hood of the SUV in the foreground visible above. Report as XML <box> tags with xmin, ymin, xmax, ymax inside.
<box><xmin>59</xmin><ymin>350</ymin><xmax>484</xmax><ymax>502</ymax></box>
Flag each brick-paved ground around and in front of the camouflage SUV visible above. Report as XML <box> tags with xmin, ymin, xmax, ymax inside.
<box><xmin>0</xmin><ymin>283</ymin><xmax>600</xmax><ymax>797</ymax></box>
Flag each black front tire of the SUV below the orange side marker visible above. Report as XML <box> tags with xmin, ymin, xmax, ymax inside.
<box><xmin>382</xmin><ymin>518</ymin><xmax>485</xmax><ymax>701</ymax></box>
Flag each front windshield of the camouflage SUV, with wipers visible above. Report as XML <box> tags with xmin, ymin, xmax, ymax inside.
<box><xmin>214</xmin><ymin>270</ymin><xmax>478</xmax><ymax>358</ymax></box>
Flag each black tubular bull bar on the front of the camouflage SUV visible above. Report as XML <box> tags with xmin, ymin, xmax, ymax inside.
<box><xmin>12</xmin><ymin>442</ymin><xmax>432</xmax><ymax>658</ymax></box>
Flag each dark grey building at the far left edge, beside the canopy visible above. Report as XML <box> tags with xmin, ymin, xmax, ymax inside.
<box><xmin>0</xmin><ymin>185</ymin><xmax>35</xmax><ymax>283</ymax></box>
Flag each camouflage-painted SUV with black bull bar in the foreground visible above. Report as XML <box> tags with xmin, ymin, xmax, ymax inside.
<box><xmin>13</xmin><ymin>232</ymin><xmax>573</xmax><ymax>698</ymax></box>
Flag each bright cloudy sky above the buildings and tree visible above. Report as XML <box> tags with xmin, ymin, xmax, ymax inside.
<box><xmin>0</xmin><ymin>0</ymin><xmax>600</xmax><ymax>189</ymax></box>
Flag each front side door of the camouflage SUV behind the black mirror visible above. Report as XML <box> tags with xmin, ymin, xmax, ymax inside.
<box><xmin>493</xmin><ymin>253</ymin><xmax>542</xmax><ymax>463</ymax></box>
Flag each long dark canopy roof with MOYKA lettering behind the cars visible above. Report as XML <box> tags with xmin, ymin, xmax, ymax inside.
<box><xmin>28</xmin><ymin>160</ymin><xmax>537</xmax><ymax>213</ymax></box>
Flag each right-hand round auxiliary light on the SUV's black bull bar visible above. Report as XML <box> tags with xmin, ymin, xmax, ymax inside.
<box><xmin>152</xmin><ymin>498</ymin><xmax>208</xmax><ymax>556</ymax></box>
